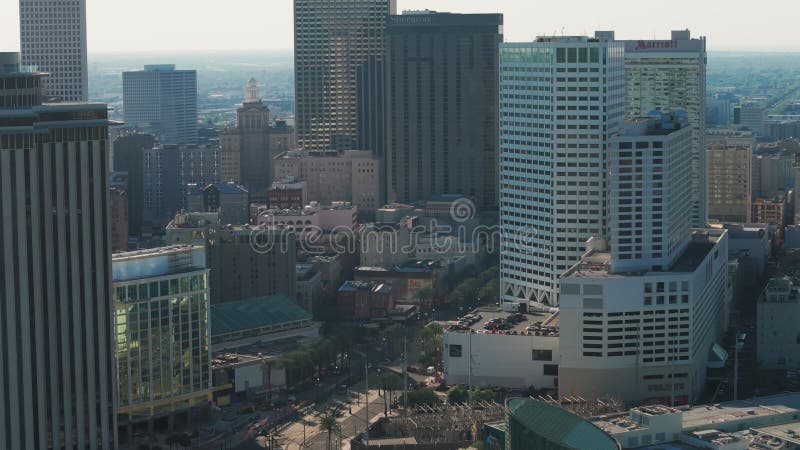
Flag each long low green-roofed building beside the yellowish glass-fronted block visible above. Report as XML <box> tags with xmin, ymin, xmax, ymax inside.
<box><xmin>210</xmin><ymin>295</ymin><xmax>313</xmax><ymax>347</ymax></box>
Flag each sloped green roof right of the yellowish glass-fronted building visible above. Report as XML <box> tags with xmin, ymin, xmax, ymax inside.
<box><xmin>209</xmin><ymin>295</ymin><xmax>311</xmax><ymax>336</ymax></box>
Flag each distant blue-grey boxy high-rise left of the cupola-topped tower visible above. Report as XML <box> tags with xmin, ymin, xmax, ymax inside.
<box><xmin>122</xmin><ymin>64</ymin><xmax>202</xmax><ymax>144</ymax></box>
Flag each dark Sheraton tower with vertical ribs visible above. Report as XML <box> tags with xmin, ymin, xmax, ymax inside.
<box><xmin>384</xmin><ymin>11</ymin><xmax>503</xmax><ymax>210</ymax></box>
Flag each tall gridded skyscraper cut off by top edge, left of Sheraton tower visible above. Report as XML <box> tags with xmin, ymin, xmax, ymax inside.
<box><xmin>294</xmin><ymin>0</ymin><xmax>396</xmax><ymax>151</ymax></box>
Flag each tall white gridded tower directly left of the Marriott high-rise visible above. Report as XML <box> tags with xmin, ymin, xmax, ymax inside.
<box><xmin>500</xmin><ymin>36</ymin><xmax>625</xmax><ymax>305</ymax></box>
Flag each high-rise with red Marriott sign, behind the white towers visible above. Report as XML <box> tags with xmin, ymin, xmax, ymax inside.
<box><xmin>616</xmin><ymin>30</ymin><xmax>707</xmax><ymax>228</ymax></box>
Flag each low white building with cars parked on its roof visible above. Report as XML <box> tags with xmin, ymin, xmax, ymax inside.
<box><xmin>443</xmin><ymin>312</ymin><xmax>560</xmax><ymax>389</ymax></box>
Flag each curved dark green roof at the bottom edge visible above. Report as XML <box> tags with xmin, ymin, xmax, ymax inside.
<box><xmin>506</xmin><ymin>398</ymin><xmax>621</xmax><ymax>450</ymax></box>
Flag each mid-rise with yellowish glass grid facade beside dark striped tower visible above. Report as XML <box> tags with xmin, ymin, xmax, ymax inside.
<box><xmin>112</xmin><ymin>245</ymin><xmax>211</xmax><ymax>425</ymax></box>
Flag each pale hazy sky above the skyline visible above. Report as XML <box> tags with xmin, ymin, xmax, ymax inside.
<box><xmin>0</xmin><ymin>0</ymin><xmax>800</xmax><ymax>53</ymax></box>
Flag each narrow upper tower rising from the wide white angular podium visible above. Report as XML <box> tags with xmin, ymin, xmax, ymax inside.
<box><xmin>608</xmin><ymin>111</ymin><xmax>692</xmax><ymax>272</ymax></box>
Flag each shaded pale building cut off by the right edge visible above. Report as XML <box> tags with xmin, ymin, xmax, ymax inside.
<box><xmin>756</xmin><ymin>277</ymin><xmax>800</xmax><ymax>370</ymax></box>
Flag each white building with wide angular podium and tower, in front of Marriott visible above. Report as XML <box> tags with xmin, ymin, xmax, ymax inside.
<box><xmin>558</xmin><ymin>112</ymin><xmax>731</xmax><ymax>405</ymax></box>
